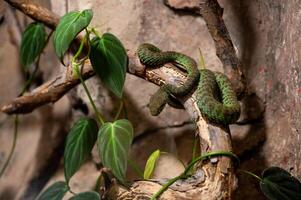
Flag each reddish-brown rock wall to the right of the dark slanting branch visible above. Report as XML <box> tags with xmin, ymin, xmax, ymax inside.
<box><xmin>220</xmin><ymin>0</ymin><xmax>301</xmax><ymax>199</ymax></box>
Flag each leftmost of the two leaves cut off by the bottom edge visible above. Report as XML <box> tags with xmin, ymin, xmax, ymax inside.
<box><xmin>37</xmin><ymin>181</ymin><xmax>69</xmax><ymax>200</ymax></box>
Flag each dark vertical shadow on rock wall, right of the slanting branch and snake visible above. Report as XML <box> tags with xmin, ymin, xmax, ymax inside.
<box><xmin>226</xmin><ymin>0</ymin><xmax>267</xmax><ymax>200</ymax></box>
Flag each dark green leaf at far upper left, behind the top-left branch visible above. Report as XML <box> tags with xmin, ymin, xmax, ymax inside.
<box><xmin>20</xmin><ymin>22</ymin><xmax>46</xmax><ymax>69</ymax></box>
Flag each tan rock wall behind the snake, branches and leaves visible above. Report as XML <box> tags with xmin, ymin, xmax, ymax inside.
<box><xmin>0</xmin><ymin>0</ymin><xmax>301</xmax><ymax>200</ymax></box>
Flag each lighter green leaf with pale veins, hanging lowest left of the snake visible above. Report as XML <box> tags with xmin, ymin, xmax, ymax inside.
<box><xmin>97</xmin><ymin>119</ymin><xmax>134</xmax><ymax>183</ymax></box>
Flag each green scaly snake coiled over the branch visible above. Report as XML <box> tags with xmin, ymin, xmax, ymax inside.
<box><xmin>137</xmin><ymin>43</ymin><xmax>240</xmax><ymax>124</ymax></box>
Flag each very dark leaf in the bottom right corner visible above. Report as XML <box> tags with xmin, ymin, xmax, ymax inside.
<box><xmin>260</xmin><ymin>167</ymin><xmax>301</xmax><ymax>200</ymax></box>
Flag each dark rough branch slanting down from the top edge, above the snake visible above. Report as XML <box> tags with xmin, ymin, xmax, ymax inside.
<box><xmin>164</xmin><ymin>0</ymin><xmax>246</xmax><ymax>96</ymax></box>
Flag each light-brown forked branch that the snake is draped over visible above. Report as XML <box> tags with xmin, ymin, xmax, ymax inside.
<box><xmin>1</xmin><ymin>0</ymin><xmax>236</xmax><ymax>200</ymax></box>
